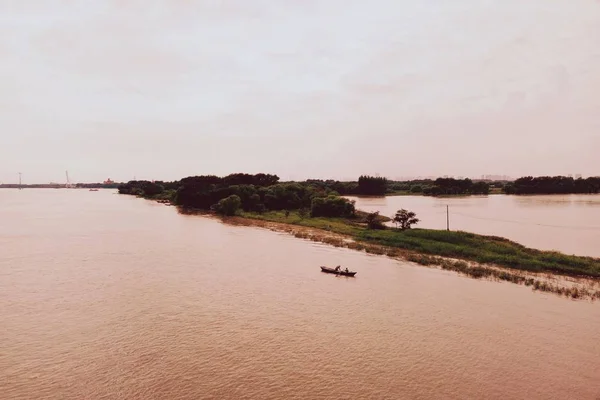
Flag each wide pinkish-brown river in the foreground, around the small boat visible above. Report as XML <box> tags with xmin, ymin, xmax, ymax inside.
<box><xmin>0</xmin><ymin>190</ymin><xmax>600</xmax><ymax>400</ymax></box>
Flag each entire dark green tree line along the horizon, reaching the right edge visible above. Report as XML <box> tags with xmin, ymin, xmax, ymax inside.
<box><xmin>119</xmin><ymin>173</ymin><xmax>600</xmax><ymax>205</ymax></box>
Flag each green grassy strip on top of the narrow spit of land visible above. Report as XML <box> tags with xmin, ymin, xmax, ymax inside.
<box><xmin>241</xmin><ymin>212</ymin><xmax>600</xmax><ymax>278</ymax></box>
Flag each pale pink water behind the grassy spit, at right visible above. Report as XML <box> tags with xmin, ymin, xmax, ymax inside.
<box><xmin>351</xmin><ymin>195</ymin><xmax>600</xmax><ymax>257</ymax></box>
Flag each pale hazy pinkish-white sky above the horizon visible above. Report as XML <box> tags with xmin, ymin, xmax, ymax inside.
<box><xmin>0</xmin><ymin>0</ymin><xmax>600</xmax><ymax>183</ymax></box>
